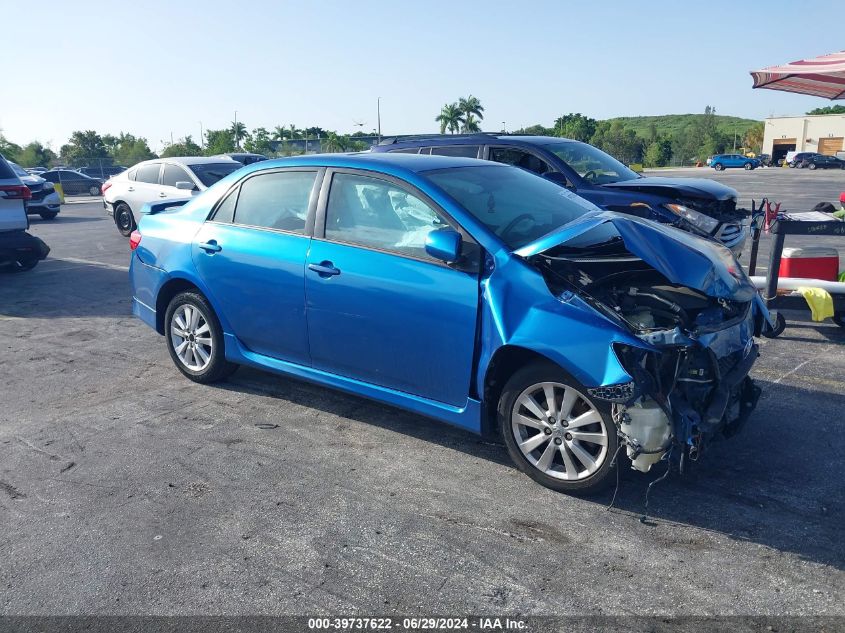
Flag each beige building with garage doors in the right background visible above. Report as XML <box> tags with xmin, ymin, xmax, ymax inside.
<box><xmin>763</xmin><ymin>114</ymin><xmax>845</xmax><ymax>162</ymax></box>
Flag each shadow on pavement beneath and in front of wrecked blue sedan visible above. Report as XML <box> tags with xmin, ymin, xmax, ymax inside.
<box><xmin>218</xmin><ymin>368</ymin><xmax>845</xmax><ymax>569</ymax></box>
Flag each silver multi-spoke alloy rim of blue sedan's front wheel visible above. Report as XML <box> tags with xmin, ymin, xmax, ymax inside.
<box><xmin>511</xmin><ymin>382</ymin><xmax>608</xmax><ymax>481</ymax></box>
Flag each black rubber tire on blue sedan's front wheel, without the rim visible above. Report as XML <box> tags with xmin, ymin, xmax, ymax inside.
<box><xmin>497</xmin><ymin>362</ymin><xmax>619</xmax><ymax>495</ymax></box>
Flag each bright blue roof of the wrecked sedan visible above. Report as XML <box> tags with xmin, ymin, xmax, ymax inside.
<box><xmin>239</xmin><ymin>152</ymin><xmax>499</xmax><ymax>173</ymax></box>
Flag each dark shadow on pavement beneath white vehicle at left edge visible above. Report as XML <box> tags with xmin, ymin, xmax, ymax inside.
<box><xmin>0</xmin><ymin>260</ymin><xmax>132</xmax><ymax>318</ymax></box>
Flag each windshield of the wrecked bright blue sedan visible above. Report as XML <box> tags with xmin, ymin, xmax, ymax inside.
<box><xmin>424</xmin><ymin>165</ymin><xmax>599</xmax><ymax>250</ymax></box>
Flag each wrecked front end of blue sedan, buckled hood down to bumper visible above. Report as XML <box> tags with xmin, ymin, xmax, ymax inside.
<box><xmin>522</xmin><ymin>214</ymin><xmax>767</xmax><ymax>472</ymax></box>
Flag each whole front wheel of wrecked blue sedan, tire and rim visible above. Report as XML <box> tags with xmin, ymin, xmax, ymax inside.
<box><xmin>498</xmin><ymin>362</ymin><xmax>619</xmax><ymax>494</ymax></box>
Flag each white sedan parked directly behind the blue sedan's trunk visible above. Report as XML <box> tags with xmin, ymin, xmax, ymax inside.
<box><xmin>103</xmin><ymin>156</ymin><xmax>243</xmax><ymax>236</ymax></box>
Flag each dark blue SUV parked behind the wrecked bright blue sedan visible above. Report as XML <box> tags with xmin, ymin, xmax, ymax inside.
<box><xmin>372</xmin><ymin>133</ymin><xmax>749</xmax><ymax>257</ymax></box>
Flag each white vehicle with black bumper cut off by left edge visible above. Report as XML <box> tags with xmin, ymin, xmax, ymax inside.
<box><xmin>0</xmin><ymin>155</ymin><xmax>50</xmax><ymax>272</ymax></box>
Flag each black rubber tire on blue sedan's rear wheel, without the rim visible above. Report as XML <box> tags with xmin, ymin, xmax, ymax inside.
<box><xmin>164</xmin><ymin>292</ymin><xmax>238</xmax><ymax>384</ymax></box>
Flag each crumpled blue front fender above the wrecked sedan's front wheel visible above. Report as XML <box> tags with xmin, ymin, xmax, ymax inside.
<box><xmin>476</xmin><ymin>251</ymin><xmax>656</xmax><ymax>393</ymax></box>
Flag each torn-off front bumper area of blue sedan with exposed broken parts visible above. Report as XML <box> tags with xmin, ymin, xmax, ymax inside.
<box><xmin>604</xmin><ymin>303</ymin><xmax>765</xmax><ymax>472</ymax></box>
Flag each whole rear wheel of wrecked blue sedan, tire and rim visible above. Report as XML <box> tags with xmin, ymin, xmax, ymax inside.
<box><xmin>164</xmin><ymin>292</ymin><xmax>238</xmax><ymax>384</ymax></box>
